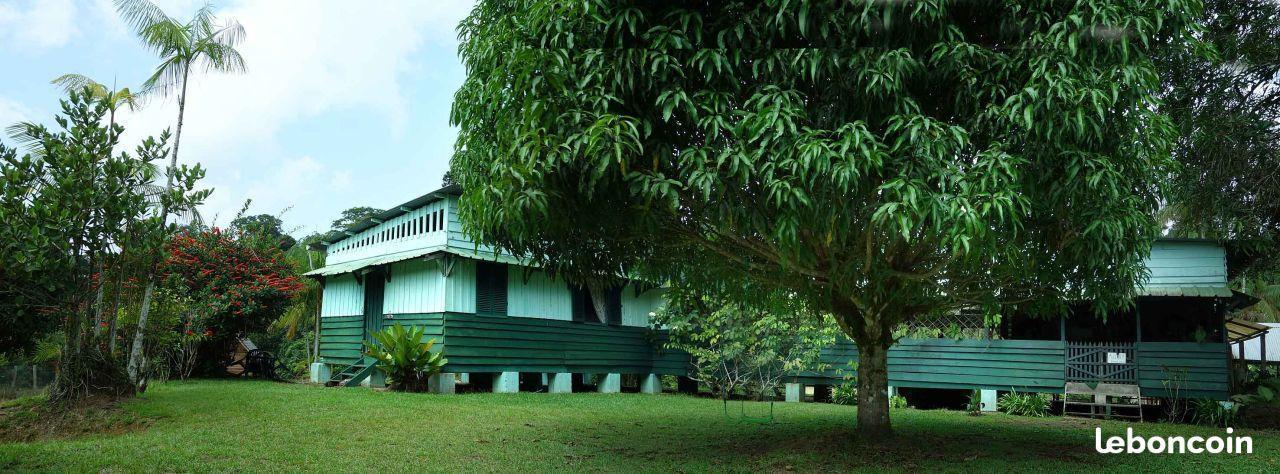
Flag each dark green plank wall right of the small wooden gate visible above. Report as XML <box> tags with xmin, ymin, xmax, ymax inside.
<box><xmin>1138</xmin><ymin>342</ymin><xmax>1228</xmax><ymax>400</ymax></box>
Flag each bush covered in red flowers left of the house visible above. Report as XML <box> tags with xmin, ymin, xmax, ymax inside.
<box><xmin>164</xmin><ymin>227</ymin><xmax>302</xmax><ymax>337</ymax></box>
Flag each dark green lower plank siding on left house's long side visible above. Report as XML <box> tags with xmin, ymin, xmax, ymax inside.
<box><xmin>444</xmin><ymin>313</ymin><xmax>689</xmax><ymax>374</ymax></box>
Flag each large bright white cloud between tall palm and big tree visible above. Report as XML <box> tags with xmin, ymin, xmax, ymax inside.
<box><xmin>112</xmin><ymin>0</ymin><xmax>471</xmax><ymax>231</ymax></box>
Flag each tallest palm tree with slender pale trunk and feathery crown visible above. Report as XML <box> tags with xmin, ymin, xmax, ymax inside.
<box><xmin>115</xmin><ymin>0</ymin><xmax>244</xmax><ymax>383</ymax></box>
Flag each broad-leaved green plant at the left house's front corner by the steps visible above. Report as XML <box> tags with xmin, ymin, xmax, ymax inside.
<box><xmin>365</xmin><ymin>323</ymin><xmax>448</xmax><ymax>392</ymax></box>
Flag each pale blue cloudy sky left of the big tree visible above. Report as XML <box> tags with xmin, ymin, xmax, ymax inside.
<box><xmin>0</xmin><ymin>0</ymin><xmax>471</xmax><ymax>236</ymax></box>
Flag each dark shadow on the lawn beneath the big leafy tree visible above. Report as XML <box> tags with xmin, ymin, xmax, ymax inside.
<box><xmin>535</xmin><ymin>410</ymin><xmax>1101</xmax><ymax>470</ymax></box>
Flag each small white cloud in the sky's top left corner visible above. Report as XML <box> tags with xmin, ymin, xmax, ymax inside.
<box><xmin>0</xmin><ymin>0</ymin><xmax>78</xmax><ymax>51</ymax></box>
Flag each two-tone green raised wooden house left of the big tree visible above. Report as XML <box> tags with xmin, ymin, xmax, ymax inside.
<box><xmin>307</xmin><ymin>187</ymin><xmax>687</xmax><ymax>392</ymax></box>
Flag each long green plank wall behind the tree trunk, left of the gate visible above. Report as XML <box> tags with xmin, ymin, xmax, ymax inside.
<box><xmin>794</xmin><ymin>339</ymin><xmax>1065</xmax><ymax>392</ymax></box>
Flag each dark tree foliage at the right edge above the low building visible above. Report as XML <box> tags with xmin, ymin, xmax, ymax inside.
<box><xmin>1155</xmin><ymin>0</ymin><xmax>1280</xmax><ymax>265</ymax></box>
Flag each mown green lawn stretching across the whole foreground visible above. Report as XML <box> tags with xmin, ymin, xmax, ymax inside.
<box><xmin>0</xmin><ymin>380</ymin><xmax>1280</xmax><ymax>471</ymax></box>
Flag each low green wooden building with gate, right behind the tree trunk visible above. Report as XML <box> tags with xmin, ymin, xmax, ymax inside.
<box><xmin>787</xmin><ymin>240</ymin><xmax>1238</xmax><ymax>409</ymax></box>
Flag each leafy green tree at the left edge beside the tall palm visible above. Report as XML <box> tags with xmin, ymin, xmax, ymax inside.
<box><xmin>0</xmin><ymin>87</ymin><xmax>209</xmax><ymax>402</ymax></box>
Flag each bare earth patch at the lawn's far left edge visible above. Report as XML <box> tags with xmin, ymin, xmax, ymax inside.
<box><xmin>0</xmin><ymin>397</ymin><xmax>151</xmax><ymax>443</ymax></box>
